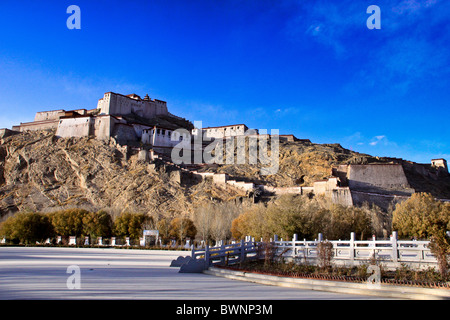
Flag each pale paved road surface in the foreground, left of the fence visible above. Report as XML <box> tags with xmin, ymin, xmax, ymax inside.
<box><xmin>0</xmin><ymin>247</ymin><xmax>386</xmax><ymax>300</ymax></box>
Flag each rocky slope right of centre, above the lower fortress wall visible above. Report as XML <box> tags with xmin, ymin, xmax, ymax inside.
<box><xmin>207</xmin><ymin>140</ymin><xmax>450</xmax><ymax>199</ymax></box>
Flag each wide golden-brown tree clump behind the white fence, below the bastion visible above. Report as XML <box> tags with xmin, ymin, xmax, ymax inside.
<box><xmin>232</xmin><ymin>195</ymin><xmax>372</xmax><ymax>240</ymax></box>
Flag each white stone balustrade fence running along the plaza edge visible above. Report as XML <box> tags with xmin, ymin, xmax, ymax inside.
<box><xmin>191</xmin><ymin>232</ymin><xmax>437</xmax><ymax>269</ymax></box>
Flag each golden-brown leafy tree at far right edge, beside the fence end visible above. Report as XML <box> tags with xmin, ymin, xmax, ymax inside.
<box><xmin>392</xmin><ymin>193</ymin><xmax>450</xmax><ymax>278</ymax></box>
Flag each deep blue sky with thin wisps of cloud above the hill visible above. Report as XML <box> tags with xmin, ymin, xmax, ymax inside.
<box><xmin>0</xmin><ymin>0</ymin><xmax>450</xmax><ymax>163</ymax></box>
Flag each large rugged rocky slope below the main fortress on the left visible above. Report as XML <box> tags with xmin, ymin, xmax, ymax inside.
<box><xmin>0</xmin><ymin>131</ymin><xmax>245</xmax><ymax>216</ymax></box>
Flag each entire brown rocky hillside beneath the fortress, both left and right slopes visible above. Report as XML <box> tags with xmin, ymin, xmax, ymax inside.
<box><xmin>0</xmin><ymin>131</ymin><xmax>450</xmax><ymax>217</ymax></box>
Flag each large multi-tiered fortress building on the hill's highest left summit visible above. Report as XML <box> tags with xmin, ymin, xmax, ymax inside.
<box><xmin>12</xmin><ymin>92</ymin><xmax>193</xmax><ymax>147</ymax></box>
